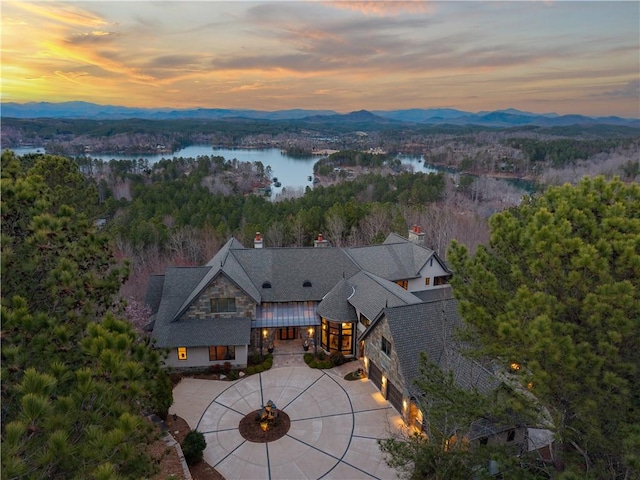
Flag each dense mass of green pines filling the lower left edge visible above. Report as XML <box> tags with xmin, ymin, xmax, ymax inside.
<box><xmin>0</xmin><ymin>153</ymin><xmax>171</xmax><ymax>479</ymax></box>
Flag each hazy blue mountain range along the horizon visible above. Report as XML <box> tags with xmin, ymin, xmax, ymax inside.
<box><xmin>0</xmin><ymin>102</ymin><xmax>640</xmax><ymax>127</ymax></box>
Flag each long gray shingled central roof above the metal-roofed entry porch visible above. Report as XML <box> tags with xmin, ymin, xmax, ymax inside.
<box><xmin>230</xmin><ymin>247</ymin><xmax>360</xmax><ymax>303</ymax></box>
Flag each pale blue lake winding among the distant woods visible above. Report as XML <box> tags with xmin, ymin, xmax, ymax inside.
<box><xmin>11</xmin><ymin>145</ymin><xmax>437</xmax><ymax>196</ymax></box>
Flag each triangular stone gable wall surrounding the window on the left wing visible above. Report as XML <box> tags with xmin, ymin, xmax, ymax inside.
<box><xmin>183</xmin><ymin>275</ymin><xmax>256</xmax><ymax>320</ymax></box>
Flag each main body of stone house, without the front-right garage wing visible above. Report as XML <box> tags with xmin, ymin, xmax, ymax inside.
<box><xmin>147</xmin><ymin>227</ymin><xmax>451</xmax><ymax>368</ymax></box>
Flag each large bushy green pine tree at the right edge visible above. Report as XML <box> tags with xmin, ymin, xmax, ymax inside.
<box><xmin>448</xmin><ymin>177</ymin><xmax>640</xmax><ymax>479</ymax></box>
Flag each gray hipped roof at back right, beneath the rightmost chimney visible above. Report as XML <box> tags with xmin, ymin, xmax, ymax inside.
<box><xmin>347</xmin><ymin>234</ymin><xmax>435</xmax><ymax>282</ymax></box>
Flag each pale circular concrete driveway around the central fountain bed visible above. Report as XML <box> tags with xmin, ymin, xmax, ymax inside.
<box><xmin>170</xmin><ymin>363</ymin><xmax>403</xmax><ymax>480</ymax></box>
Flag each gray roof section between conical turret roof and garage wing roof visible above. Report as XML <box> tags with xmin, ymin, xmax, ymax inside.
<box><xmin>349</xmin><ymin>271</ymin><xmax>420</xmax><ymax>321</ymax></box>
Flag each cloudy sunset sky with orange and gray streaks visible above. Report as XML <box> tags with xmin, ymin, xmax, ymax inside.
<box><xmin>2</xmin><ymin>0</ymin><xmax>640</xmax><ymax>117</ymax></box>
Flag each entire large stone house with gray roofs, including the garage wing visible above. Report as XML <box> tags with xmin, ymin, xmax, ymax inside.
<box><xmin>147</xmin><ymin>226</ymin><xmax>556</xmax><ymax>456</ymax></box>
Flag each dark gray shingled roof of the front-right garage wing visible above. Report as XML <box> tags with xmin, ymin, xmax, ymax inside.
<box><xmin>385</xmin><ymin>298</ymin><xmax>500</xmax><ymax>394</ymax></box>
